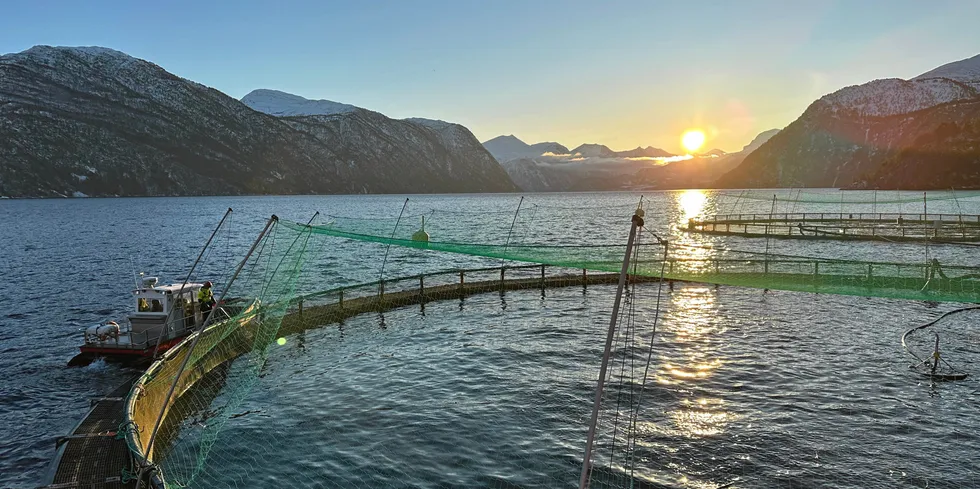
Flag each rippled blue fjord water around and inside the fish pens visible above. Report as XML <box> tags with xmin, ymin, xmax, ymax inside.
<box><xmin>0</xmin><ymin>192</ymin><xmax>980</xmax><ymax>487</ymax></box>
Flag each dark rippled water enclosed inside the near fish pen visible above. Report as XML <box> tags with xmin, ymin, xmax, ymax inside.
<box><xmin>172</xmin><ymin>285</ymin><xmax>980</xmax><ymax>488</ymax></box>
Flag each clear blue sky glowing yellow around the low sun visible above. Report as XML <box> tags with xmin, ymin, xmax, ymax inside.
<box><xmin>0</xmin><ymin>0</ymin><xmax>980</xmax><ymax>153</ymax></box>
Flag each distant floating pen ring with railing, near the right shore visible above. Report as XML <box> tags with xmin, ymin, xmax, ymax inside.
<box><xmin>682</xmin><ymin>212</ymin><xmax>980</xmax><ymax>243</ymax></box>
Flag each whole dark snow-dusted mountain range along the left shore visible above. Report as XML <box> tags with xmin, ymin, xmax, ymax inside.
<box><xmin>0</xmin><ymin>46</ymin><xmax>515</xmax><ymax>197</ymax></box>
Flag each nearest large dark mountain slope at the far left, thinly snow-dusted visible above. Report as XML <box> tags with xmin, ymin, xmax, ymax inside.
<box><xmin>0</xmin><ymin>46</ymin><xmax>350</xmax><ymax>197</ymax></box>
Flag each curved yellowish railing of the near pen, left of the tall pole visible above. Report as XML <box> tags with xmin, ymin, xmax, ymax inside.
<box><xmin>126</xmin><ymin>264</ymin><xmax>628</xmax><ymax>487</ymax></box>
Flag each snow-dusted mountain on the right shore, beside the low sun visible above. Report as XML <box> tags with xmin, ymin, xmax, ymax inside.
<box><xmin>717</xmin><ymin>52</ymin><xmax>980</xmax><ymax>188</ymax></box>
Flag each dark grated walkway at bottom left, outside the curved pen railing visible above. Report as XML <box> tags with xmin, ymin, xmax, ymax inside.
<box><xmin>40</xmin><ymin>377</ymin><xmax>136</xmax><ymax>489</ymax></box>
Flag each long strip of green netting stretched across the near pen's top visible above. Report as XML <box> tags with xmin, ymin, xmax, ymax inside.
<box><xmin>283</xmin><ymin>215</ymin><xmax>980</xmax><ymax>302</ymax></box>
